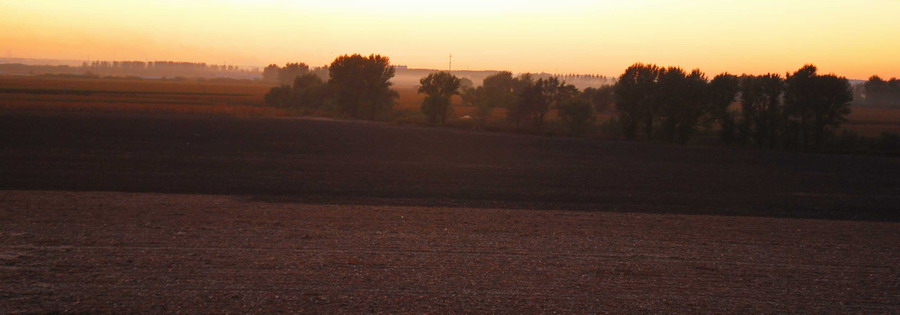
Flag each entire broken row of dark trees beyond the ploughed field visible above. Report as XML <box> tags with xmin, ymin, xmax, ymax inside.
<box><xmin>264</xmin><ymin>54</ymin><xmax>893</xmax><ymax>154</ymax></box>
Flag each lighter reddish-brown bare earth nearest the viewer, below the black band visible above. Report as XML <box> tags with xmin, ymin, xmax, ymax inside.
<box><xmin>0</xmin><ymin>191</ymin><xmax>900</xmax><ymax>314</ymax></box>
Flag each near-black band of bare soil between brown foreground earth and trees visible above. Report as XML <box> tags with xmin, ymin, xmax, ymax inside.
<box><xmin>0</xmin><ymin>113</ymin><xmax>900</xmax><ymax>221</ymax></box>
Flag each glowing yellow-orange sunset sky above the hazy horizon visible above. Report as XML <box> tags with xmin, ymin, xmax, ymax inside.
<box><xmin>0</xmin><ymin>0</ymin><xmax>900</xmax><ymax>79</ymax></box>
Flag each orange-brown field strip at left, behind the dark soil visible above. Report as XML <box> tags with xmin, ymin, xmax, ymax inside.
<box><xmin>0</xmin><ymin>76</ymin><xmax>290</xmax><ymax>116</ymax></box>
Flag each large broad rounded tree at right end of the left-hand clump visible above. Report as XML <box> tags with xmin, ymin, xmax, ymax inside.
<box><xmin>328</xmin><ymin>54</ymin><xmax>398</xmax><ymax>120</ymax></box>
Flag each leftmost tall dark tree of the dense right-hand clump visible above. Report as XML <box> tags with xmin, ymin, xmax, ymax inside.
<box><xmin>614</xmin><ymin>63</ymin><xmax>663</xmax><ymax>139</ymax></box>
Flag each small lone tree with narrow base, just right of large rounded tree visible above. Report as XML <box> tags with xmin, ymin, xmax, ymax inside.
<box><xmin>419</xmin><ymin>71</ymin><xmax>461</xmax><ymax>124</ymax></box>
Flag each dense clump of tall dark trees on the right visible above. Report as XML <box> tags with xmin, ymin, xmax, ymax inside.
<box><xmin>615</xmin><ymin>64</ymin><xmax>853</xmax><ymax>149</ymax></box>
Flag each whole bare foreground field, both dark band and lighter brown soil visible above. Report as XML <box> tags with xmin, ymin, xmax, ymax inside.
<box><xmin>0</xmin><ymin>112</ymin><xmax>900</xmax><ymax>313</ymax></box>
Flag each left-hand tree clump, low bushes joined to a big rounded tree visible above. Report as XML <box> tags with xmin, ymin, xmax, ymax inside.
<box><xmin>264</xmin><ymin>54</ymin><xmax>398</xmax><ymax>120</ymax></box>
